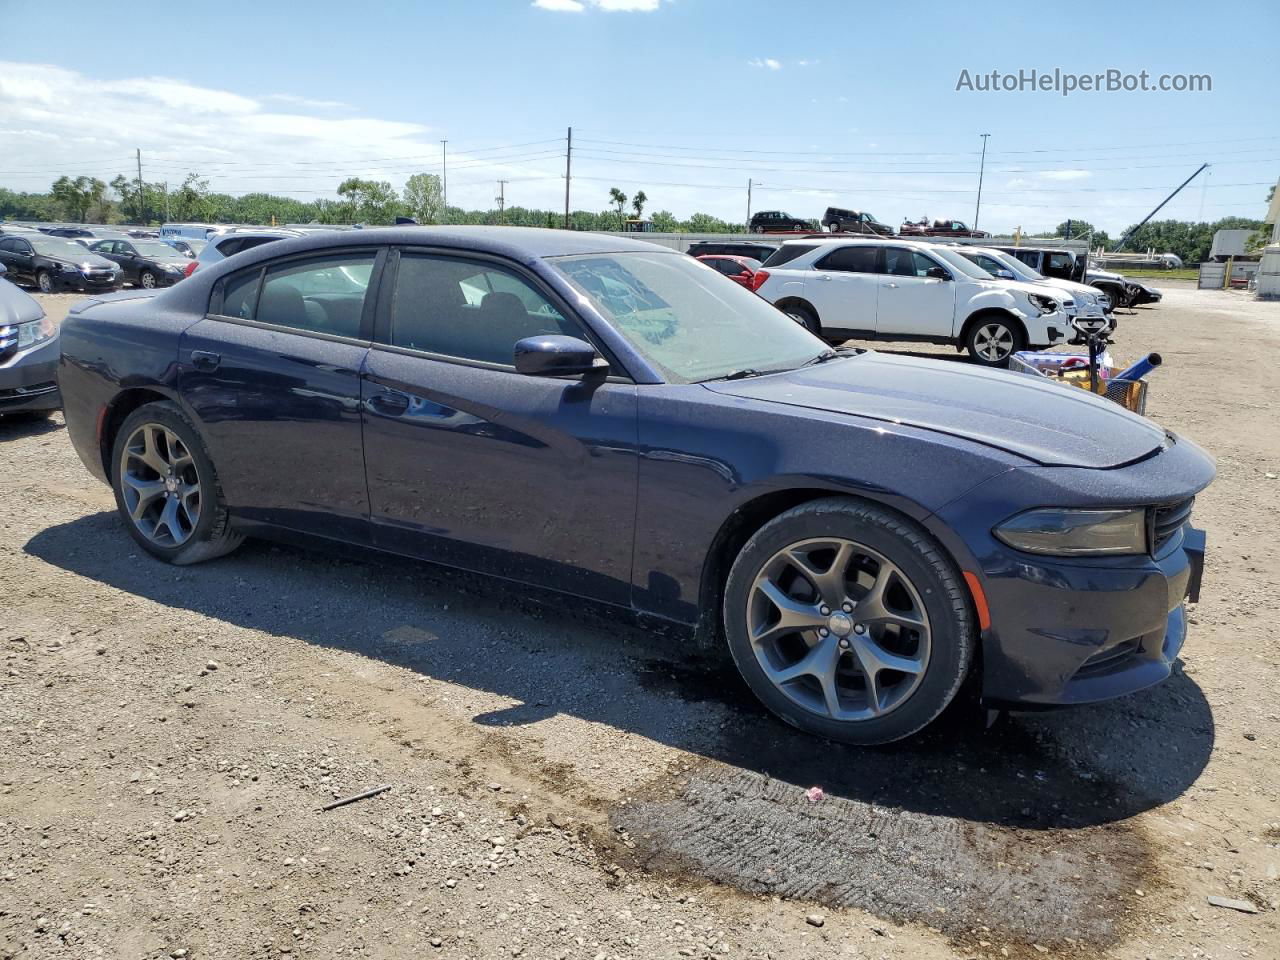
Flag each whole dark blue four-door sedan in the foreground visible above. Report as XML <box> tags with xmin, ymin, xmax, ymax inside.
<box><xmin>59</xmin><ymin>227</ymin><xmax>1213</xmax><ymax>744</ymax></box>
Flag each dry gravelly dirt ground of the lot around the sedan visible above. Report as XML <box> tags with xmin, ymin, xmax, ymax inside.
<box><xmin>0</xmin><ymin>283</ymin><xmax>1280</xmax><ymax>960</ymax></box>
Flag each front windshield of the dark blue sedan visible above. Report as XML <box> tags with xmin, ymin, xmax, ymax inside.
<box><xmin>549</xmin><ymin>251</ymin><xmax>827</xmax><ymax>383</ymax></box>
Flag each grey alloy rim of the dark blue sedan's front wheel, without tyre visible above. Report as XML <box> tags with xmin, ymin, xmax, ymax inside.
<box><xmin>746</xmin><ymin>536</ymin><xmax>931</xmax><ymax>721</ymax></box>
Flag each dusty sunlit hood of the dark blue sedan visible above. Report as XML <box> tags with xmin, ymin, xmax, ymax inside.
<box><xmin>704</xmin><ymin>352</ymin><xmax>1165</xmax><ymax>468</ymax></box>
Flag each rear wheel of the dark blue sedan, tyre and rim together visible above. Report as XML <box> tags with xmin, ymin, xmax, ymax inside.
<box><xmin>111</xmin><ymin>402</ymin><xmax>243</xmax><ymax>564</ymax></box>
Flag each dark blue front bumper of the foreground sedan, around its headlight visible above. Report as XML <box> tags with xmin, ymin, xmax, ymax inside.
<box><xmin>931</xmin><ymin>438</ymin><xmax>1213</xmax><ymax>709</ymax></box>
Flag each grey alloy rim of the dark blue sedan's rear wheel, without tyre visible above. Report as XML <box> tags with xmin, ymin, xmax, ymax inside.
<box><xmin>119</xmin><ymin>424</ymin><xmax>202</xmax><ymax>547</ymax></box>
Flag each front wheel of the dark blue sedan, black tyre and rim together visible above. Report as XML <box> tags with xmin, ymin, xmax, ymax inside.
<box><xmin>723</xmin><ymin>497</ymin><xmax>975</xmax><ymax>744</ymax></box>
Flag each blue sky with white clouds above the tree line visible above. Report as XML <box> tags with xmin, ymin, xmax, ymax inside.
<box><xmin>0</xmin><ymin>0</ymin><xmax>1280</xmax><ymax>237</ymax></box>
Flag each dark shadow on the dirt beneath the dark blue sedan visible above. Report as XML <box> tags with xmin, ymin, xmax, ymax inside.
<box><xmin>26</xmin><ymin>512</ymin><xmax>1215</xmax><ymax>829</ymax></box>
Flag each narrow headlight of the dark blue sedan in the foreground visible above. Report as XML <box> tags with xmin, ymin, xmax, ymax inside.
<box><xmin>993</xmin><ymin>508</ymin><xmax>1147</xmax><ymax>557</ymax></box>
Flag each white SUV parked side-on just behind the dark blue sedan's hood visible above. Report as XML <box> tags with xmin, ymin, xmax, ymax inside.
<box><xmin>755</xmin><ymin>239</ymin><xmax>1075</xmax><ymax>366</ymax></box>
